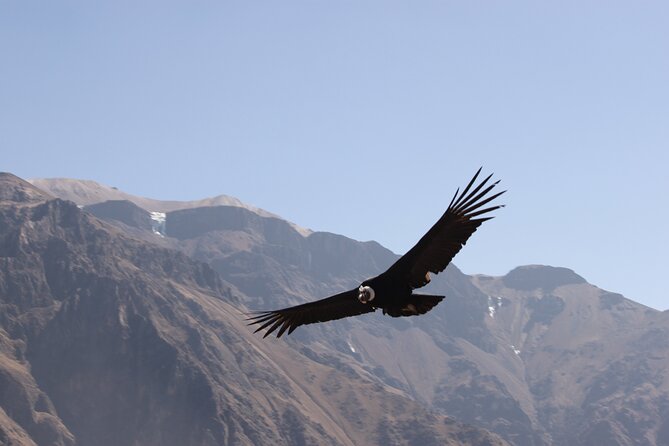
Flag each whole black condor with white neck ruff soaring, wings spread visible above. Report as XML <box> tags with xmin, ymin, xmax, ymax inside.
<box><xmin>247</xmin><ymin>169</ymin><xmax>506</xmax><ymax>338</ymax></box>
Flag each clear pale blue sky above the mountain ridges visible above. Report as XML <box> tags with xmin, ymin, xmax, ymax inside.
<box><xmin>0</xmin><ymin>0</ymin><xmax>669</xmax><ymax>309</ymax></box>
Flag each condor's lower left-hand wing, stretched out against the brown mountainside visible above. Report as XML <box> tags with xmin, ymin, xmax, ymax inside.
<box><xmin>248</xmin><ymin>289</ymin><xmax>374</xmax><ymax>338</ymax></box>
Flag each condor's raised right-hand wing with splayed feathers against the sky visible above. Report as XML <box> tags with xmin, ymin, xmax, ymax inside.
<box><xmin>384</xmin><ymin>169</ymin><xmax>506</xmax><ymax>289</ymax></box>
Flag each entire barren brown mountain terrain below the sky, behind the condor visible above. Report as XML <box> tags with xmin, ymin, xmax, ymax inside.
<box><xmin>0</xmin><ymin>174</ymin><xmax>669</xmax><ymax>446</ymax></box>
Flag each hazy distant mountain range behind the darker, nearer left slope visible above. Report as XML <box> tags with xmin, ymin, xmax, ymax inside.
<box><xmin>43</xmin><ymin>176</ymin><xmax>669</xmax><ymax>445</ymax></box>
